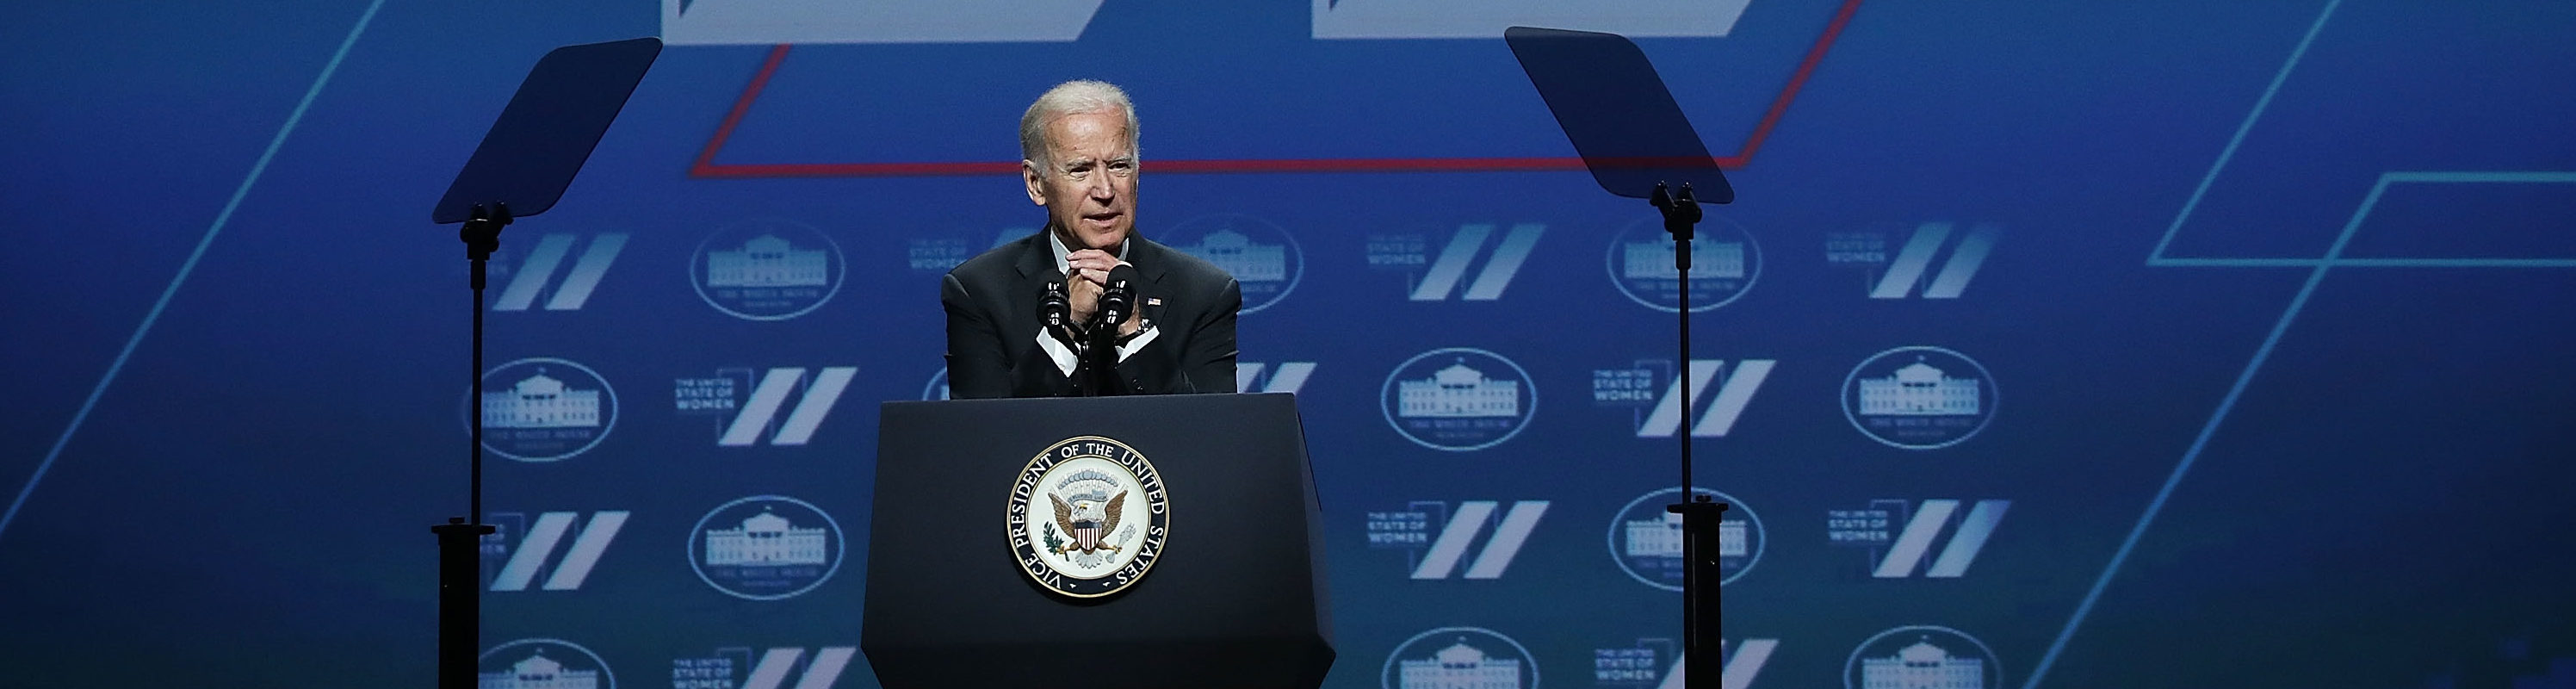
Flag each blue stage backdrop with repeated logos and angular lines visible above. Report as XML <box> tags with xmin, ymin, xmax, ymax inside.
<box><xmin>0</xmin><ymin>0</ymin><xmax>2576</xmax><ymax>689</ymax></box>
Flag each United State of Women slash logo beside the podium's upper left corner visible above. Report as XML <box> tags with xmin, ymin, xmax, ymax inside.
<box><xmin>672</xmin><ymin>366</ymin><xmax>858</xmax><ymax>446</ymax></box>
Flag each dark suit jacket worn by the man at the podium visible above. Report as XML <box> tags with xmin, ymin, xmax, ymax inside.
<box><xmin>940</xmin><ymin>230</ymin><xmax>1244</xmax><ymax>400</ymax></box>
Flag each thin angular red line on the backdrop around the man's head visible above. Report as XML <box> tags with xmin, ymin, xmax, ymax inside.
<box><xmin>688</xmin><ymin>0</ymin><xmax>1860</xmax><ymax>178</ymax></box>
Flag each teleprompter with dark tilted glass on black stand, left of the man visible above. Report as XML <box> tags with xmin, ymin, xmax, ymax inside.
<box><xmin>430</xmin><ymin>39</ymin><xmax>662</xmax><ymax>689</ymax></box>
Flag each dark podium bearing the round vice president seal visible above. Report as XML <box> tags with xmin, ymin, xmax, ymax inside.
<box><xmin>860</xmin><ymin>394</ymin><xmax>1334</xmax><ymax>689</ymax></box>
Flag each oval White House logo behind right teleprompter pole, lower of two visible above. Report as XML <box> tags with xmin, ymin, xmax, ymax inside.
<box><xmin>1610</xmin><ymin>487</ymin><xmax>1770</xmax><ymax>591</ymax></box>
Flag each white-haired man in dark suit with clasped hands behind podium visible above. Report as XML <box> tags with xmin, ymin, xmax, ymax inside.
<box><xmin>940</xmin><ymin>80</ymin><xmax>1244</xmax><ymax>397</ymax></box>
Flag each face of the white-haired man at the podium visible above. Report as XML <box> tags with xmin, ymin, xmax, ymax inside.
<box><xmin>1020</xmin><ymin>111</ymin><xmax>1136</xmax><ymax>253</ymax></box>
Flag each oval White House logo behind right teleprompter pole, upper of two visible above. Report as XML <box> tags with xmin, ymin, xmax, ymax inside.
<box><xmin>1607</xmin><ymin>217</ymin><xmax>1762</xmax><ymax>313</ymax></box>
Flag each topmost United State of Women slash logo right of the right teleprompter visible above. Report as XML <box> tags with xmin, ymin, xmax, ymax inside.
<box><xmin>1824</xmin><ymin>222</ymin><xmax>2004</xmax><ymax>300</ymax></box>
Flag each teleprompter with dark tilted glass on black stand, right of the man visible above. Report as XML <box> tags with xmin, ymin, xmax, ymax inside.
<box><xmin>1504</xmin><ymin>26</ymin><xmax>1737</xmax><ymax>689</ymax></box>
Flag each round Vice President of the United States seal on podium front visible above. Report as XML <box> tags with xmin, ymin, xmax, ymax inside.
<box><xmin>1007</xmin><ymin>436</ymin><xmax>1172</xmax><ymax>599</ymax></box>
